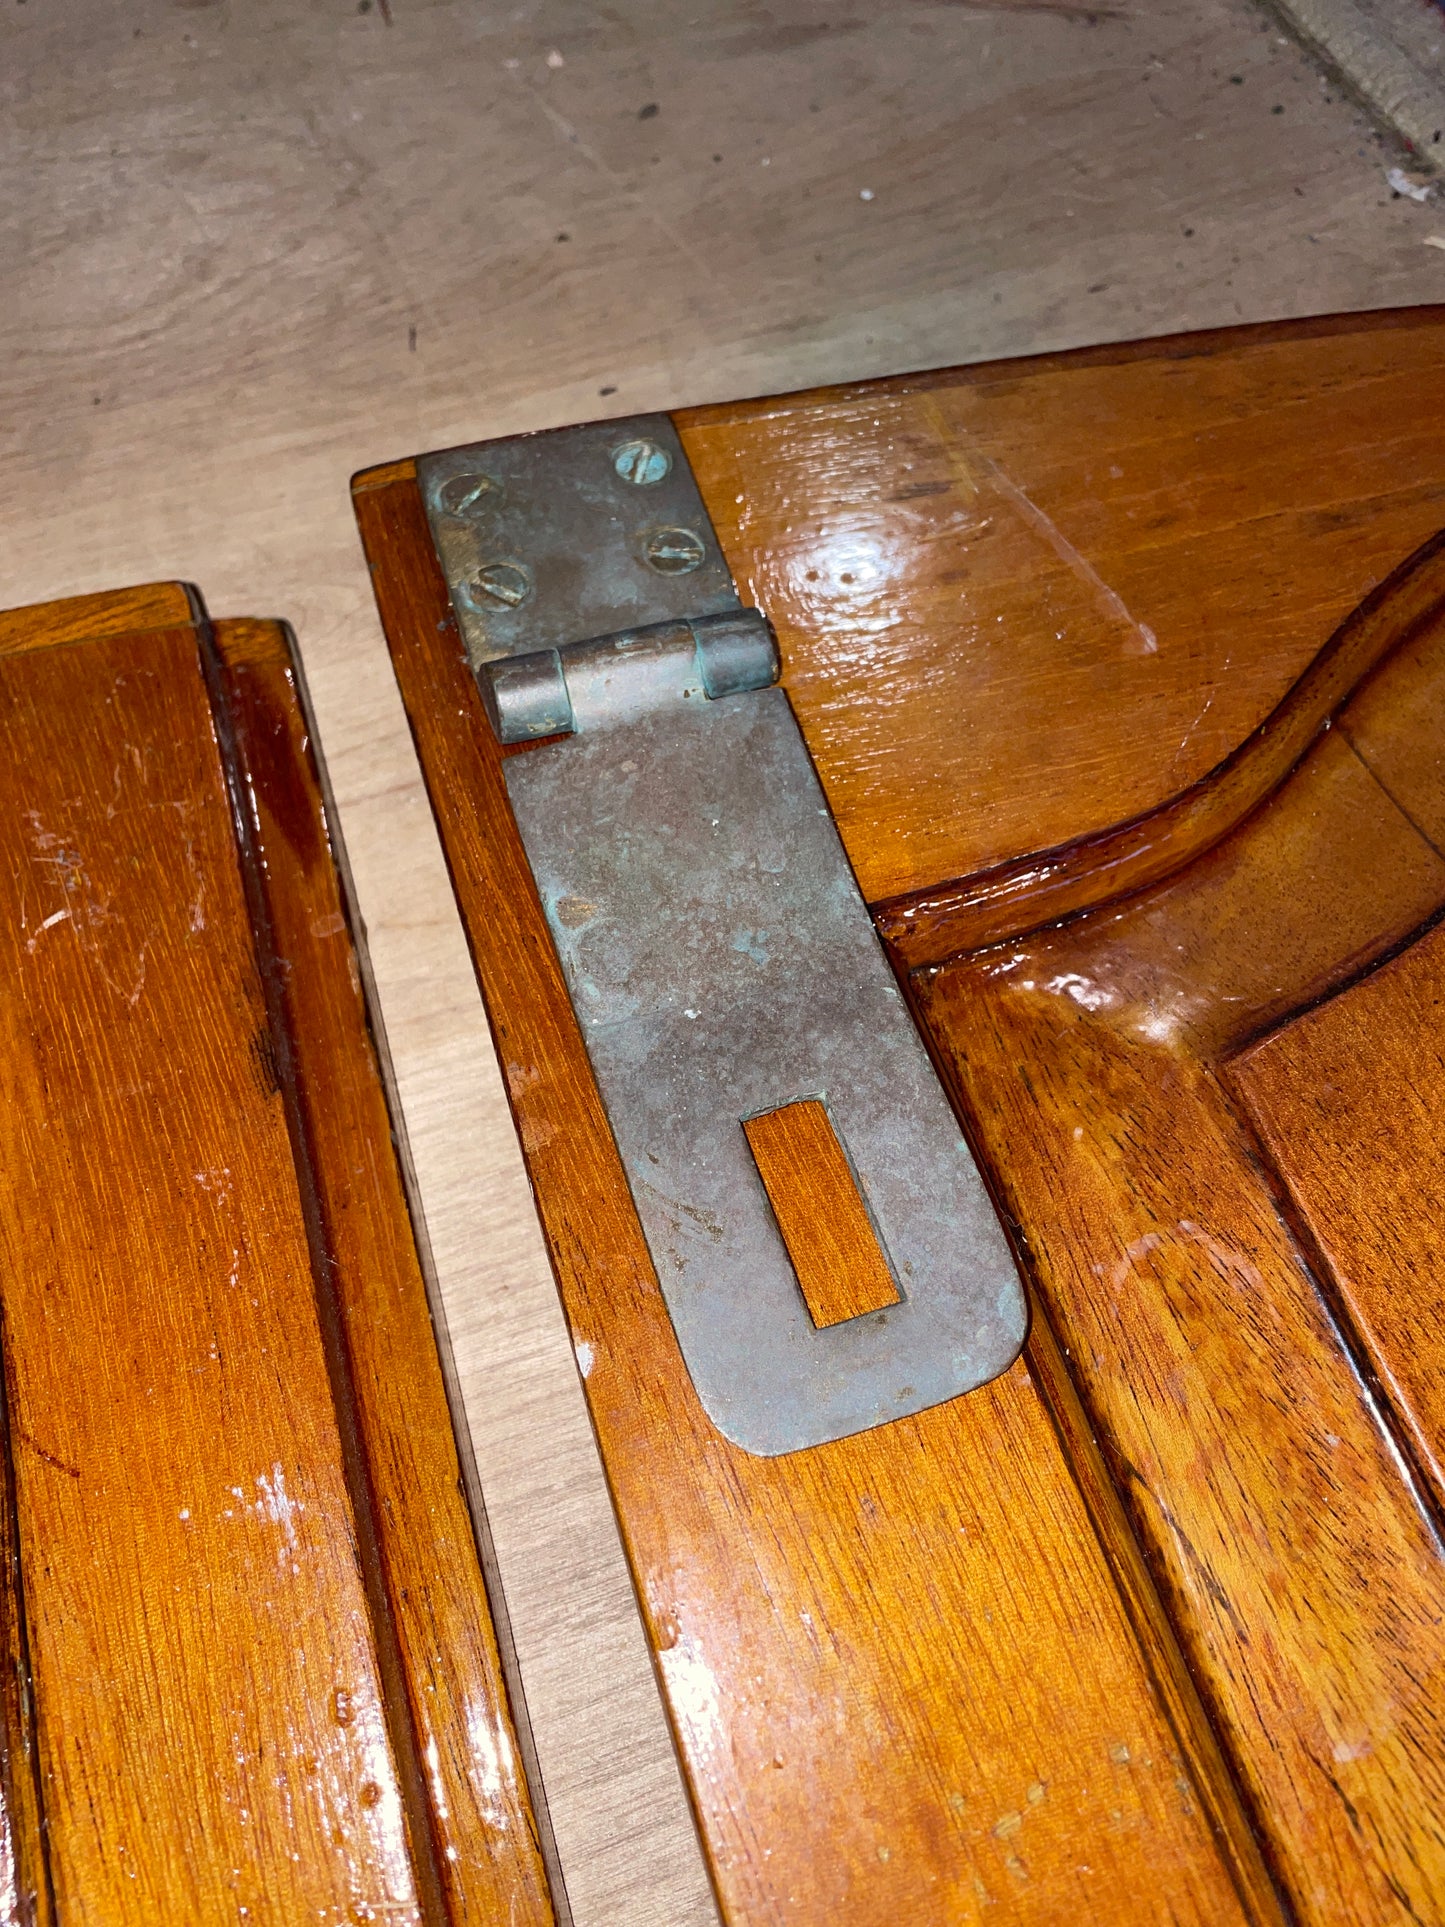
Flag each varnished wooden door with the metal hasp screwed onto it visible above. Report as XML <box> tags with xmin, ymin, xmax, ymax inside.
<box><xmin>355</xmin><ymin>310</ymin><xmax>1445</xmax><ymax>1927</ymax></box>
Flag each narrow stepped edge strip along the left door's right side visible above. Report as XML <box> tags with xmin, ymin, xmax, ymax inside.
<box><xmin>216</xmin><ymin>622</ymin><xmax>553</xmax><ymax>1927</ymax></box>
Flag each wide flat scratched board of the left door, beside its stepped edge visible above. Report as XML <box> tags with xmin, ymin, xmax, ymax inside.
<box><xmin>0</xmin><ymin>605</ymin><xmax>433</xmax><ymax>1923</ymax></box>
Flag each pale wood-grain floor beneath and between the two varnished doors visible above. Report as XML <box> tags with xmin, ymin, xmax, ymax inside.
<box><xmin>0</xmin><ymin>0</ymin><xmax>1445</xmax><ymax>1927</ymax></box>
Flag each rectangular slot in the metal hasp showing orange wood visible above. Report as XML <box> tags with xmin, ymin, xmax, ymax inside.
<box><xmin>744</xmin><ymin>1096</ymin><xmax>900</xmax><ymax>1330</ymax></box>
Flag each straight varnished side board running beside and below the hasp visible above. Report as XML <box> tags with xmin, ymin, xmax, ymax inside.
<box><xmin>356</xmin><ymin>466</ymin><xmax>1275</xmax><ymax>1927</ymax></box>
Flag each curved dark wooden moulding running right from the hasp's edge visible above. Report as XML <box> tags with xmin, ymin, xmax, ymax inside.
<box><xmin>871</xmin><ymin>530</ymin><xmax>1445</xmax><ymax>969</ymax></box>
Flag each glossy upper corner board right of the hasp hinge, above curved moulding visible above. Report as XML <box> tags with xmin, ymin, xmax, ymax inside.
<box><xmin>678</xmin><ymin>308</ymin><xmax>1445</xmax><ymax>913</ymax></box>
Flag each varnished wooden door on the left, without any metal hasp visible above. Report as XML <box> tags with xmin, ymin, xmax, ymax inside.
<box><xmin>0</xmin><ymin>586</ymin><xmax>551</xmax><ymax>1923</ymax></box>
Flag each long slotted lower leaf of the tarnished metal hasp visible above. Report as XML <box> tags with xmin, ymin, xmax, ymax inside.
<box><xmin>430</xmin><ymin>418</ymin><xmax>1027</xmax><ymax>1455</ymax></box>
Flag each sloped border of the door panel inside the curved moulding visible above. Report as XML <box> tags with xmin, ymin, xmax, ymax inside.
<box><xmin>913</xmin><ymin>574</ymin><xmax>1445</xmax><ymax>1923</ymax></box>
